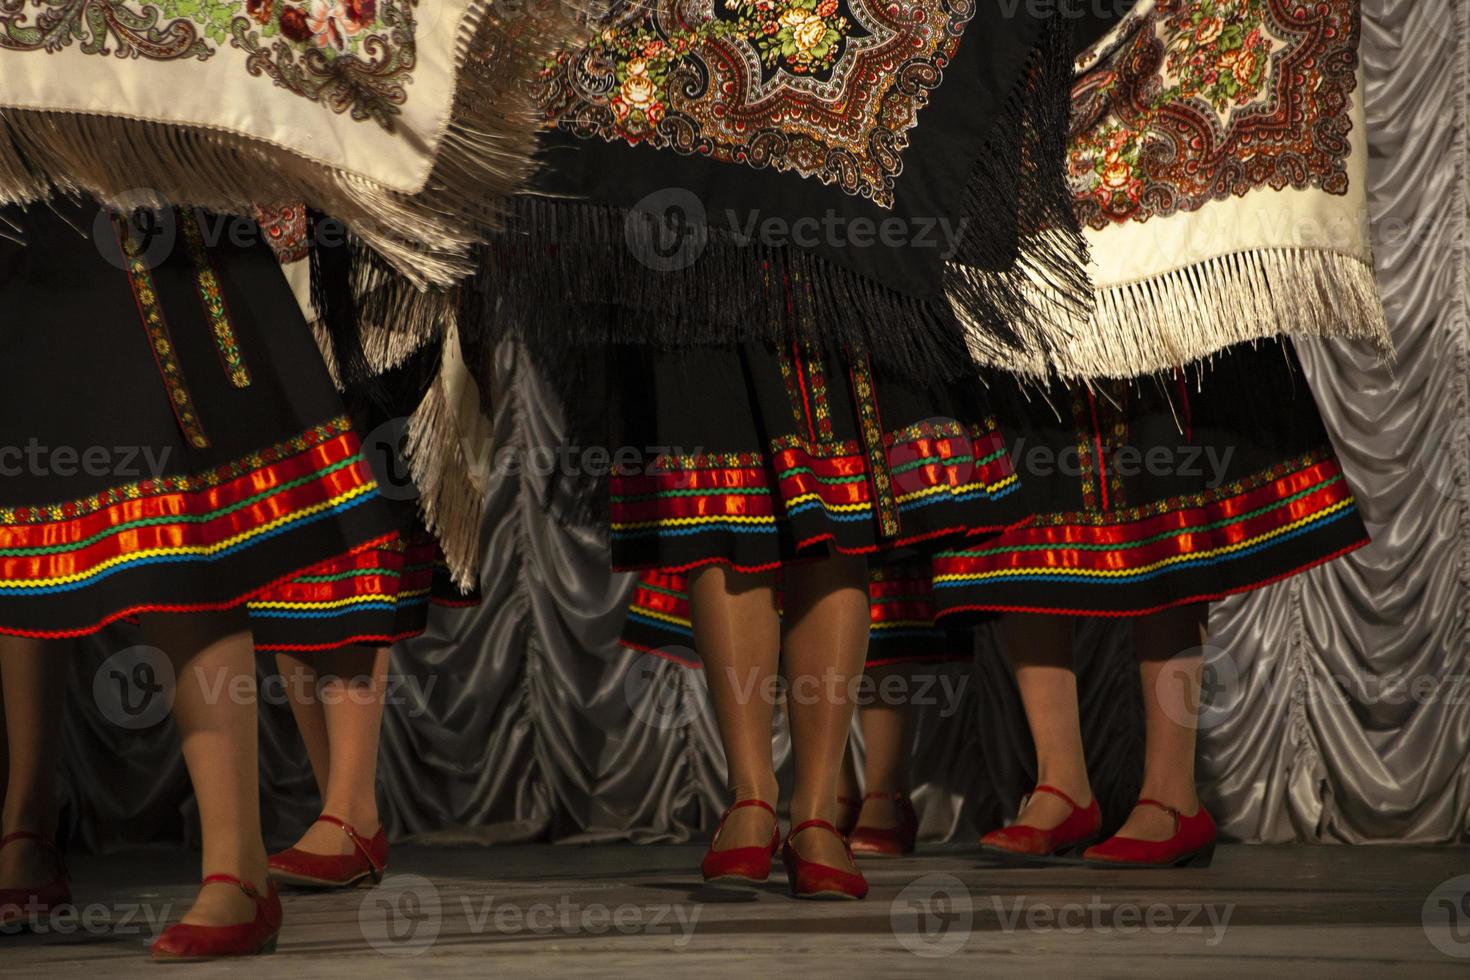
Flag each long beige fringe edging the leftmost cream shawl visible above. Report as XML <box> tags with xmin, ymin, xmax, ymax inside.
<box><xmin>0</xmin><ymin>0</ymin><xmax>585</xmax><ymax>290</ymax></box>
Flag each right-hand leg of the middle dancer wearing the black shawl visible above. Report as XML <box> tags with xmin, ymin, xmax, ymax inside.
<box><xmin>784</xmin><ymin>555</ymin><xmax>870</xmax><ymax>870</ymax></box>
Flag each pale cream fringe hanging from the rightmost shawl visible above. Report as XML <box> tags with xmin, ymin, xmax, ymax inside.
<box><xmin>972</xmin><ymin>247</ymin><xmax>1394</xmax><ymax>379</ymax></box>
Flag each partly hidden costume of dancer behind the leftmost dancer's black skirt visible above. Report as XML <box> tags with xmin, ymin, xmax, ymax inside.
<box><xmin>248</xmin><ymin>204</ymin><xmax>484</xmax><ymax>652</ymax></box>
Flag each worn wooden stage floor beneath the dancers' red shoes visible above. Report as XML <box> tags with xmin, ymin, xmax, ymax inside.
<box><xmin>0</xmin><ymin>845</ymin><xmax>1470</xmax><ymax>980</ymax></box>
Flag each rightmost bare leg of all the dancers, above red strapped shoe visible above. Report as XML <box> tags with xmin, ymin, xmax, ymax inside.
<box><xmin>1119</xmin><ymin>604</ymin><xmax>1210</xmax><ymax>840</ymax></box>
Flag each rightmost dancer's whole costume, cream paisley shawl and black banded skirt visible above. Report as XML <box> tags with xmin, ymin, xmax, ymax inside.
<box><xmin>933</xmin><ymin>0</ymin><xmax>1388</xmax><ymax>623</ymax></box>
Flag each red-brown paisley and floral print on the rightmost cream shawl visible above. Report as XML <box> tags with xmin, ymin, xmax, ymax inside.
<box><xmin>1069</xmin><ymin>0</ymin><xmax>1360</xmax><ymax>229</ymax></box>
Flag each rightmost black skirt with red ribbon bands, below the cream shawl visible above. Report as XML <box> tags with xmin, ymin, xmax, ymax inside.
<box><xmin>933</xmin><ymin>341</ymin><xmax>1369</xmax><ymax>623</ymax></box>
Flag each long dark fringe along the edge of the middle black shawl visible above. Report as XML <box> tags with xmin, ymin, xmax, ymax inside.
<box><xmin>460</xmin><ymin>16</ymin><xmax>1091</xmax><ymax>391</ymax></box>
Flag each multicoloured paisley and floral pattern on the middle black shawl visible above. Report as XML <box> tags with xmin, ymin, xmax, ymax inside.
<box><xmin>542</xmin><ymin>0</ymin><xmax>975</xmax><ymax>207</ymax></box>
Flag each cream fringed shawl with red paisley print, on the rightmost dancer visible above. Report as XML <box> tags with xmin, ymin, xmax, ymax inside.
<box><xmin>997</xmin><ymin>0</ymin><xmax>1391</xmax><ymax>378</ymax></box>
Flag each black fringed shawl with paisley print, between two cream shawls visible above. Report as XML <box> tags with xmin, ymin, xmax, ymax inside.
<box><xmin>470</xmin><ymin>0</ymin><xmax>1091</xmax><ymax>376</ymax></box>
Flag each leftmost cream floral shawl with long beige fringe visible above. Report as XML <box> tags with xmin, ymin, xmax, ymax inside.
<box><xmin>0</xmin><ymin>0</ymin><xmax>576</xmax><ymax>287</ymax></box>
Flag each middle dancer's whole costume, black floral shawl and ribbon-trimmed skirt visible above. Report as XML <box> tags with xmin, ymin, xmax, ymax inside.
<box><xmin>466</xmin><ymin>0</ymin><xmax>1089</xmax><ymax>572</ymax></box>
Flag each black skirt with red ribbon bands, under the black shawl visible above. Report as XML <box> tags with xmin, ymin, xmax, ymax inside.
<box><xmin>609</xmin><ymin>342</ymin><xmax>1029</xmax><ymax>572</ymax></box>
